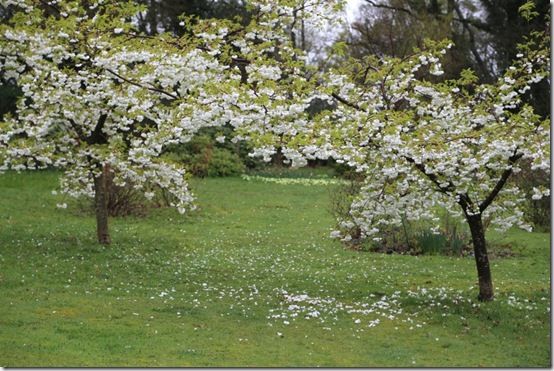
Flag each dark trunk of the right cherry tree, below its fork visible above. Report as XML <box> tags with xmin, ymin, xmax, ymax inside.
<box><xmin>466</xmin><ymin>214</ymin><xmax>494</xmax><ymax>301</ymax></box>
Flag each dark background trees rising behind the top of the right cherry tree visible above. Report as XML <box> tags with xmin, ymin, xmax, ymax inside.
<box><xmin>345</xmin><ymin>0</ymin><xmax>550</xmax><ymax>117</ymax></box>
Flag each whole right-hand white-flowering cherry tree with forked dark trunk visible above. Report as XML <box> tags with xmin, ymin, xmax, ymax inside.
<box><xmin>291</xmin><ymin>22</ymin><xmax>550</xmax><ymax>300</ymax></box>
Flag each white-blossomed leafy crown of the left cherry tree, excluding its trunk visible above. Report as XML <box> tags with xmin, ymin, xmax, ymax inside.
<box><xmin>0</xmin><ymin>0</ymin><xmax>340</xmax><ymax>212</ymax></box>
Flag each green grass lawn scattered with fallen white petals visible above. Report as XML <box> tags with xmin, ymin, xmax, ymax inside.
<box><xmin>0</xmin><ymin>172</ymin><xmax>551</xmax><ymax>367</ymax></box>
